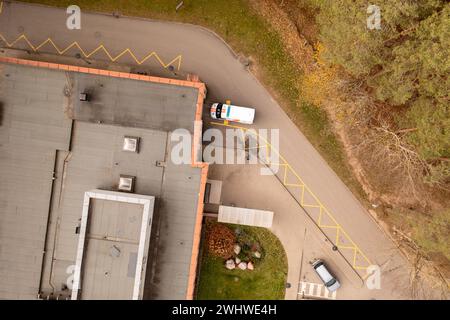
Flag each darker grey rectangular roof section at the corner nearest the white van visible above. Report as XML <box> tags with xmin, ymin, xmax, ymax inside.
<box><xmin>71</xmin><ymin>73</ymin><xmax>198</xmax><ymax>132</ymax></box>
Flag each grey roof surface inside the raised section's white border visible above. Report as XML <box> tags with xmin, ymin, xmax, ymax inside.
<box><xmin>80</xmin><ymin>199</ymin><xmax>143</xmax><ymax>300</ymax></box>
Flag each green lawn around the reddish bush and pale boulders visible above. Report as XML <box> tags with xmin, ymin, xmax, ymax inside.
<box><xmin>197</xmin><ymin>225</ymin><xmax>287</xmax><ymax>300</ymax></box>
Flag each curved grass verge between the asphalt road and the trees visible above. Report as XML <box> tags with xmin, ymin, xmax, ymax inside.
<box><xmin>25</xmin><ymin>0</ymin><xmax>363</xmax><ymax>200</ymax></box>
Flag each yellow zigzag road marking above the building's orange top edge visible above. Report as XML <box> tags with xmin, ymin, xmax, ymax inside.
<box><xmin>0</xmin><ymin>33</ymin><xmax>182</xmax><ymax>70</ymax></box>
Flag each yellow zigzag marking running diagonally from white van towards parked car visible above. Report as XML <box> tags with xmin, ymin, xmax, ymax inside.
<box><xmin>212</xmin><ymin>122</ymin><xmax>371</xmax><ymax>270</ymax></box>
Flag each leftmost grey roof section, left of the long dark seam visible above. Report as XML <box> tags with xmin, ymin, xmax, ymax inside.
<box><xmin>0</xmin><ymin>65</ymin><xmax>71</xmax><ymax>299</ymax></box>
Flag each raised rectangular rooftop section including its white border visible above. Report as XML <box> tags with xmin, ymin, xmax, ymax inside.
<box><xmin>71</xmin><ymin>189</ymin><xmax>155</xmax><ymax>300</ymax></box>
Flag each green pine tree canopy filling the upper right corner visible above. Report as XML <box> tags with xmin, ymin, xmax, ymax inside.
<box><xmin>311</xmin><ymin>0</ymin><xmax>450</xmax><ymax>175</ymax></box>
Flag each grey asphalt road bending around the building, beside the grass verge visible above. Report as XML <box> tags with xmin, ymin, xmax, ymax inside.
<box><xmin>0</xmin><ymin>3</ymin><xmax>440</xmax><ymax>299</ymax></box>
